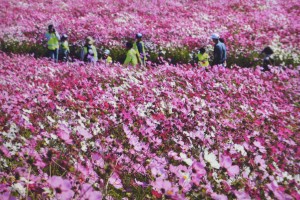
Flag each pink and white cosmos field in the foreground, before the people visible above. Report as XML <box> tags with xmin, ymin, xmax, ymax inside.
<box><xmin>0</xmin><ymin>53</ymin><xmax>300</xmax><ymax>200</ymax></box>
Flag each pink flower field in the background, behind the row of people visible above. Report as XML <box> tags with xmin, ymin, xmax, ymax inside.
<box><xmin>0</xmin><ymin>0</ymin><xmax>300</xmax><ymax>64</ymax></box>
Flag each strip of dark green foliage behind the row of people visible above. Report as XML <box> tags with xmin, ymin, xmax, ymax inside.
<box><xmin>0</xmin><ymin>41</ymin><xmax>300</xmax><ymax>67</ymax></box>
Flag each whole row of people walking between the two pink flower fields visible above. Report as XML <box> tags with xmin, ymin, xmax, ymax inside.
<box><xmin>46</xmin><ymin>25</ymin><xmax>273</xmax><ymax>71</ymax></box>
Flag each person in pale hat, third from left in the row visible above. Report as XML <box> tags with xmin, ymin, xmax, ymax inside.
<box><xmin>80</xmin><ymin>36</ymin><xmax>98</xmax><ymax>63</ymax></box>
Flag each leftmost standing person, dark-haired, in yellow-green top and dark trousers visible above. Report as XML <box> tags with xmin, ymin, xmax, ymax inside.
<box><xmin>45</xmin><ymin>24</ymin><xmax>60</xmax><ymax>62</ymax></box>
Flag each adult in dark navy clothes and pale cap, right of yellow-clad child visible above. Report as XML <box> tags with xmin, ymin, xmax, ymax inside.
<box><xmin>211</xmin><ymin>33</ymin><xmax>227</xmax><ymax>66</ymax></box>
